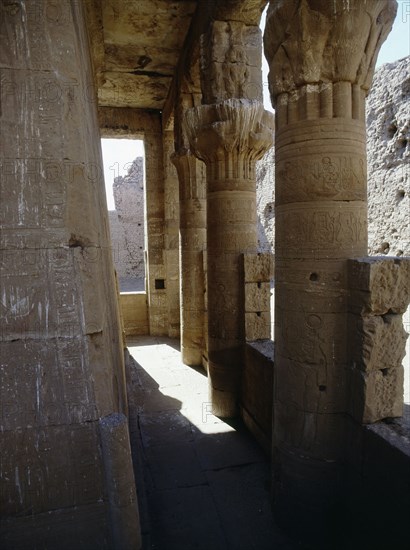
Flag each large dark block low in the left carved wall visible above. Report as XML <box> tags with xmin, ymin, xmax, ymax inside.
<box><xmin>0</xmin><ymin>424</ymin><xmax>104</xmax><ymax>519</ymax></box>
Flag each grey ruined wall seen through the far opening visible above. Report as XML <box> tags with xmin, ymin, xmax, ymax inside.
<box><xmin>108</xmin><ymin>157</ymin><xmax>145</xmax><ymax>290</ymax></box>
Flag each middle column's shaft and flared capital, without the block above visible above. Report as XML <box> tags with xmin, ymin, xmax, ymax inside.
<box><xmin>186</xmin><ymin>100</ymin><xmax>272</xmax><ymax>416</ymax></box>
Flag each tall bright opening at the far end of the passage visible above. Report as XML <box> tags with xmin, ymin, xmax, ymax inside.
<box><xmin>101</xmin><ymin>138</ymin><xmax>145</xmax><ymax>292</ymax></box>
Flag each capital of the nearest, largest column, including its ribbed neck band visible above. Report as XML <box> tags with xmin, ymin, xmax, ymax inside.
<box><xmin>264</xmin><ymin>0</ymin><xmax>397</xmax><ymax>127</ymax></box>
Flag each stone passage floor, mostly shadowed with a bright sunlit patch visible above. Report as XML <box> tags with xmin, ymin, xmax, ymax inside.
<box><xmin>127</xmin><ymin>336</ymin><xmax>297</xmax><ymax>550</ymax></box>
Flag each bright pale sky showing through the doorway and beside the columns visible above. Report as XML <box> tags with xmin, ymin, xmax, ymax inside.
<box><xmin>101</xmin><ymin>0</ymin><xmax>410</xmax><ymax>210</ymax></box>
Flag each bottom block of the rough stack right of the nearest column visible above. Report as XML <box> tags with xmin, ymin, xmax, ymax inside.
<box><xmin>349</xmin><ymin>366</ymin><xmax>404</xmax><ymax>424</ymax></box>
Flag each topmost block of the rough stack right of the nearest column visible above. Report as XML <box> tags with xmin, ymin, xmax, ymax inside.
<box><xmin>348</xmin><ymin>257</ymin><xmax>410</xmax><ymax>315</ymax></box>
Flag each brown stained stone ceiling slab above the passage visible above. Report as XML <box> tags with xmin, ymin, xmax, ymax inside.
<box><xmin>86</xmin><ymin>0</ymin><xmax>196</xmax><ymax>109</ymax></box>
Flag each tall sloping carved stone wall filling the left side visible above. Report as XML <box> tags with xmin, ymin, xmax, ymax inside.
<box><xmin>0</xmin><ymin>0</ymin><xmax>140</xmax><ymax>549</ymax></box>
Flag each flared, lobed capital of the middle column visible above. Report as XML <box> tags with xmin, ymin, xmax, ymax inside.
<box><xmin>185</xmin><ymin>99</ymin><xmax>274</xmax><ymax>179</ymax></box>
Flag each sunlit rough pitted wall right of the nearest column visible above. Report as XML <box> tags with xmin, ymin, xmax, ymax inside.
<box><xmin>366</xmin><ymin>57</ymin><xmax>410</xmax><ymax>256</ymax></box>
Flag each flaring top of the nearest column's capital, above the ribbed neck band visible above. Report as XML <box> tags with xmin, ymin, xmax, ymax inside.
<box><xmin>264</xmin><ymin>0</ymin><xmax>397</xmax><ymax>98</ymax></box>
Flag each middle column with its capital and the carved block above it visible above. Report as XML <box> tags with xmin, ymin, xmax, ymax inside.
<box><xmin>185</xmin><ymin>21</ymin><xmax>273</xmax><ymax>417</ymax></box>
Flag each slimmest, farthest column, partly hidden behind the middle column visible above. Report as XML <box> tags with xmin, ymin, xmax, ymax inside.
<box><xmin>172</xmin><ymin>149</ymin><xmax>206</xmax><ymax>366</ymax></box>
